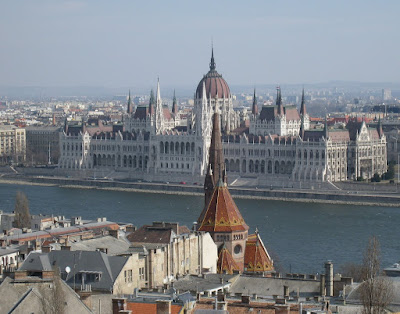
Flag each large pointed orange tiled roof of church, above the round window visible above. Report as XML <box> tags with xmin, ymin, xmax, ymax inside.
<box><xmin>199</xmin><ymin>180</ymin><xmax>249</xmax><ymax>232</ymax></box>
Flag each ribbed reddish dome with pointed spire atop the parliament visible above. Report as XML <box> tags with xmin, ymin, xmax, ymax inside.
<box><xmin>196</xmin><ymin>51</ymin><xmax>231</xmax><ymax>99</ymax></box>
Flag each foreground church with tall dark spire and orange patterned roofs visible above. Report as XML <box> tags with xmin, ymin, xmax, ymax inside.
<box><xmin>197</xmin><ymin>113</ymin><xmax>274</xmax><ymax>275</ymax></box>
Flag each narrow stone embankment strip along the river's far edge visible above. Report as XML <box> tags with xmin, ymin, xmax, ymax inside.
<box><xmin>0</xmin><ymin>176</ymin><xmax>400</xmax><ymax>207</ymax></box>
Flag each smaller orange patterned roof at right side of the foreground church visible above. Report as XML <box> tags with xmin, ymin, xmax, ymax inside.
<box><xmin>244</xmin><ymin>231</ymin><xmax>274</xmax><ymax>272</ymax></box>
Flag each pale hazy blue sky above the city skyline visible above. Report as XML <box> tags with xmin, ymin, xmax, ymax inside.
<box><xmin>0</xmin><ymin>0</ymin><xmax>400</xmax><ymax>90</ymax></box>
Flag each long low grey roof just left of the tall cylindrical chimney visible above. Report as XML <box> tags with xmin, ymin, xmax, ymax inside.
<box><xmin>229</xmin><ymin>275</ymin><xmax>320</xmax><ymax>298</ymax></box>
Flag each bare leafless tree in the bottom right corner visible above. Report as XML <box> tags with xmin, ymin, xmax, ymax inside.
<box><xmin>360</xmin><ymin>237</ymin><xmax>393</xmax><ymax>314</ymax></box>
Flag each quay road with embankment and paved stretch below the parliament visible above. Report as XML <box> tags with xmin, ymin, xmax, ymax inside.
<box><xmin>0</xmin><ymin>174</ymin><xmax>400</xmax><ymax>207</ymax></box>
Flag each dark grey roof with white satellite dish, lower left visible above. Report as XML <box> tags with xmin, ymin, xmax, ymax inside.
<box><xmin>19</xmin><ymin>251</ymin><xmax>129</xmax><ymax>291</ymax></box>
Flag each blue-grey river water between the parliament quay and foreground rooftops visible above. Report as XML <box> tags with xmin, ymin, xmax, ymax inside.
<box><xmin>0</xmin><ymin>184</ymin><xmax>400</xmax><ymax>273</ymax></box>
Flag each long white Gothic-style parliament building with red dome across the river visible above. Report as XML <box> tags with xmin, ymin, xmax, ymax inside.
<box><xmin>58</xmin><ymin>53</ymin><xmax>387</xmax><ymax>186</ymax></box>
